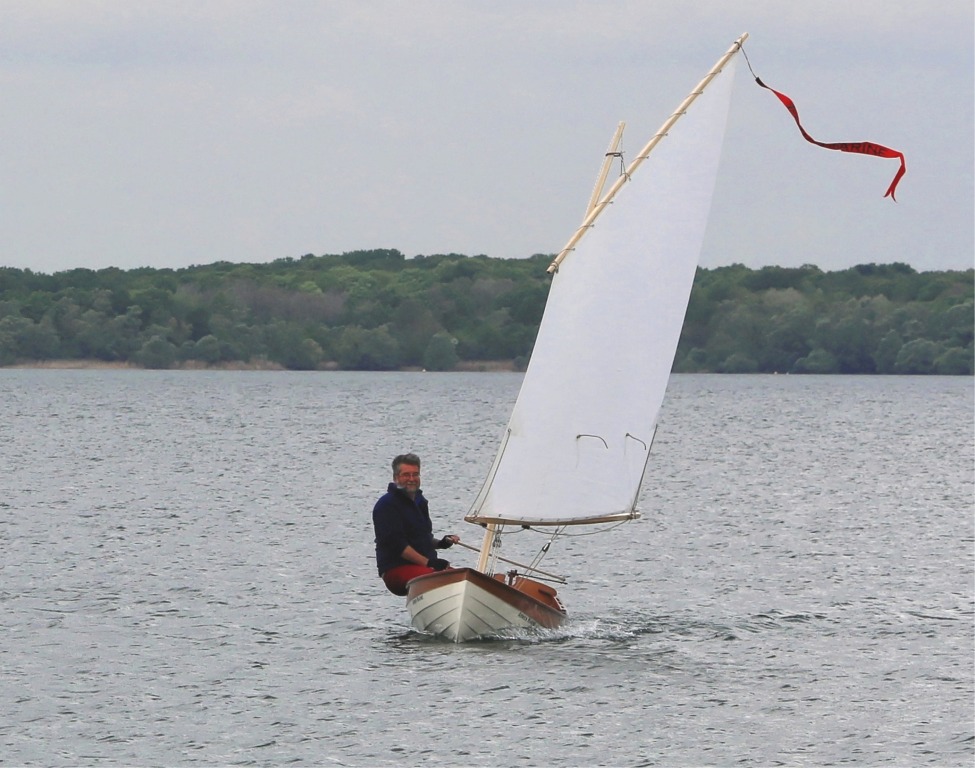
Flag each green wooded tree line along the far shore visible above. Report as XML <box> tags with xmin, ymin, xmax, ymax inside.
<box><xmin>0</xmin><ymin>249</ymin><xmax>975</xmax><ymax>375</ymax></box>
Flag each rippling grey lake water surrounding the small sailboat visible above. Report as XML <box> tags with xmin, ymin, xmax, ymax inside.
<box><xmin>0</xmin><ymin>370</ymin><xmax>975</xmax><ymax>766</ymax></box>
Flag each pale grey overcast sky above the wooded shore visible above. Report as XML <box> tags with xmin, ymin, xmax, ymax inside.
<box><xmin>0</xmin><ymin>0</ymin><xmax>975</xmax><ymax>273</ymax></box>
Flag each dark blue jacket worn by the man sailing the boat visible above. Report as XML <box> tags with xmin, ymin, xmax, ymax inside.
<box><xmin>372</xmin><ymin>483</ymin><xmax>436</xmax><ymax>576</ymax></box>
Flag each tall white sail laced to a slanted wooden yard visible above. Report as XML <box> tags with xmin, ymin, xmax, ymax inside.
<box><xmin>466</xmin><ymin>58</ymin><xmax>734</xmax><ymax>525</ymax></box>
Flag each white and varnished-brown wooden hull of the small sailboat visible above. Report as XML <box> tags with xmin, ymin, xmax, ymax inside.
<box><xmin>406</xmin><ymin>568</ymin><xmax>566</xmax><ymax>643</ymax></box>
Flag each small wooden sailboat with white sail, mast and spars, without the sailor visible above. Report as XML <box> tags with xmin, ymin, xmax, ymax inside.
<box><xmin>407</xmin><ymin>34</ymin><xmax>748</xmax><ymax>642</ymax></box>
